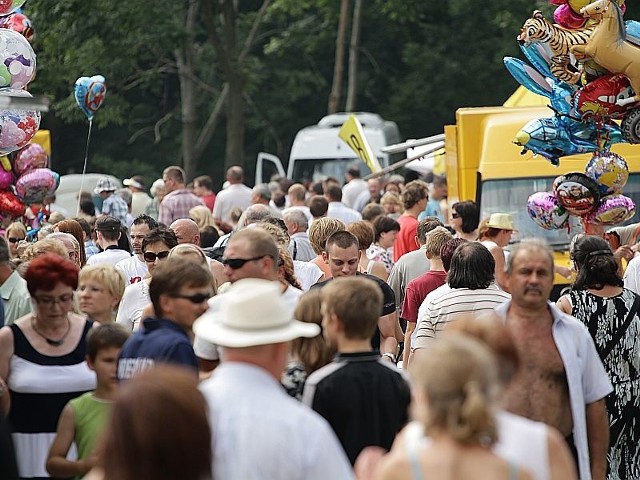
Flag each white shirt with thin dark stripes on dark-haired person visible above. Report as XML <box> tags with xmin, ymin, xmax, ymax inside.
<box><xmin>414</xmin><ymin>283</ymin><xmax>511</xmax><ymax>349</ymax></box>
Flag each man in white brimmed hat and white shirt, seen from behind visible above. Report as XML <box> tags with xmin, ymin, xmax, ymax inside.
<box><xmin>194</xmin><ymin>278</ymin><xmax>353</xmax><ymax>480</ymax></box>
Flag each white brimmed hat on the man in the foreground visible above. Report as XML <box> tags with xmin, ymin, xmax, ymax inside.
<box><xmin>193</xmin><ymin>278</ymin><xmax>320</xmax><ymax>348</ymax></box>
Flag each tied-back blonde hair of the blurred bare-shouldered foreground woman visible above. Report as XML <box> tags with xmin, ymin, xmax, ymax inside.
<box><xmin>410</xmin><ymin>333</ymin><xmax>497</xmax><ymax>447</ymax></box>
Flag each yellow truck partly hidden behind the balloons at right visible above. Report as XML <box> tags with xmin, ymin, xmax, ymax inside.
<box><xmin>445</xmin><ymin>106</ymin><xmax>640</xmax><ymax>298</ymax></box>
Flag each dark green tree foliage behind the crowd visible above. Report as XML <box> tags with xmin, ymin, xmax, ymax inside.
<box><xmin>18</xmin><ymin>0</ymin><xmax>640</xmax><ymax>185</ymax></box>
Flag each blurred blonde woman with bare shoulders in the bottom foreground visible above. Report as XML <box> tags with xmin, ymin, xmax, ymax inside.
<box><xmin>374</xmin><ymin>334</ymin><xmax>531</xmax><ymax>480</ymax></box>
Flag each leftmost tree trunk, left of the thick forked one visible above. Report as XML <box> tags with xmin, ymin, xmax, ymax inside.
<box><xmin>175</xmin><ymin>0</ymin><xmax>198</xmax><ymax>179</ymax></box>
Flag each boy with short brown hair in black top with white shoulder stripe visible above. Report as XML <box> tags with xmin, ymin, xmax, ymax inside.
<box><xmin>302</xmin><ymin>277</ymin><xmax>411</xmax><ymax>464</ymax></box>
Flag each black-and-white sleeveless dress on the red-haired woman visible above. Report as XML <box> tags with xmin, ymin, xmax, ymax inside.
<box><xmin>7</xmin><ymin>321</ymin><xmax>96</xmax><ymax>478</ymax></box>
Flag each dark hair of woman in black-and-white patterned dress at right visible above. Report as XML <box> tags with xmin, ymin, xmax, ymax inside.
<box><xmin>571</xmin><ymin>235</ymin><xmax>624</xmax><ymax>290</ymax></box>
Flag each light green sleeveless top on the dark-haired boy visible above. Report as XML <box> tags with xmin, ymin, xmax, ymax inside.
<box><xmin>69</xmin><ymin>392</ymin><xmax>113</xmax><ymax>459</ymax></box>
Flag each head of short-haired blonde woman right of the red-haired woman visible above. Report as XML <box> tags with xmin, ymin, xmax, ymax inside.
<box><xmin>78</xmin><ymin>264</ymin><xmax>125</xmax><ymax>323</ymax></box>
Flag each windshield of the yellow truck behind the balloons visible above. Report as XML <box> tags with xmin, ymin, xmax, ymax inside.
<box><xmin>480</xmin><ymin>173</ymin><xmax>640</xmax><ymax>250</ymax></box>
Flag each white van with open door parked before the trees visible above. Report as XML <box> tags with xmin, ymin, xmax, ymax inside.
<box><xmin>256</xmin><ymin>112</ymin><xmax>400</xmax><ymax>184</ymax></box>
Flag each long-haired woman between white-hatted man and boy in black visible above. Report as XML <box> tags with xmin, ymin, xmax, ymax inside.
<box><xmin>280</xmin><ymin>288</ymin><xmax>334</xmax><ymax>400</ymax></box>
